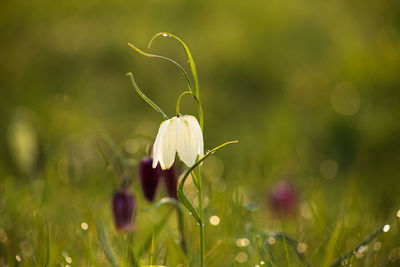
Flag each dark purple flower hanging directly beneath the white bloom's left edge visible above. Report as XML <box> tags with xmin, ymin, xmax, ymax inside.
<box><xmin>139</xmin><ymin>157</ymin><xmax>161</xmax><ymax>202</ymax></box>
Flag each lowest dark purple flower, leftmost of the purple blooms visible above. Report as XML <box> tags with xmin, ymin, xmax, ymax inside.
<box><xmin>112</xmin><ymin>190</ymin><xmax>136</xmax><ymax>231</ymax></box>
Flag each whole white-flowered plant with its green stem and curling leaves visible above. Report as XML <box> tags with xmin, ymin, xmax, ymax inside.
<box><xmin>127</xmin><ymin>32</ymin><xmax>238</xmax><ymax>267</ymax></box>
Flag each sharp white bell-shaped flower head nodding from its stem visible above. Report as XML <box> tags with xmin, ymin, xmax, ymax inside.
<box><xmin>153</xmin><ymin>115</ymin><xmax>204</xmax><ymax>170</ymax></box>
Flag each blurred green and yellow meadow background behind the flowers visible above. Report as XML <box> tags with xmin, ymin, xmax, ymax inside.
<box><xmin>0</xmin><ymin>0</ymin><xmax>400</xmax><ymax>266</ymax></box>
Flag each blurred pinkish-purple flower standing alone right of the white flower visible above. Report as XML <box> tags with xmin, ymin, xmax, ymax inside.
<box><xmin>270</xmin><ymin>181</ymin><xmax>297</xmax><ymax>215</ymax></box>
